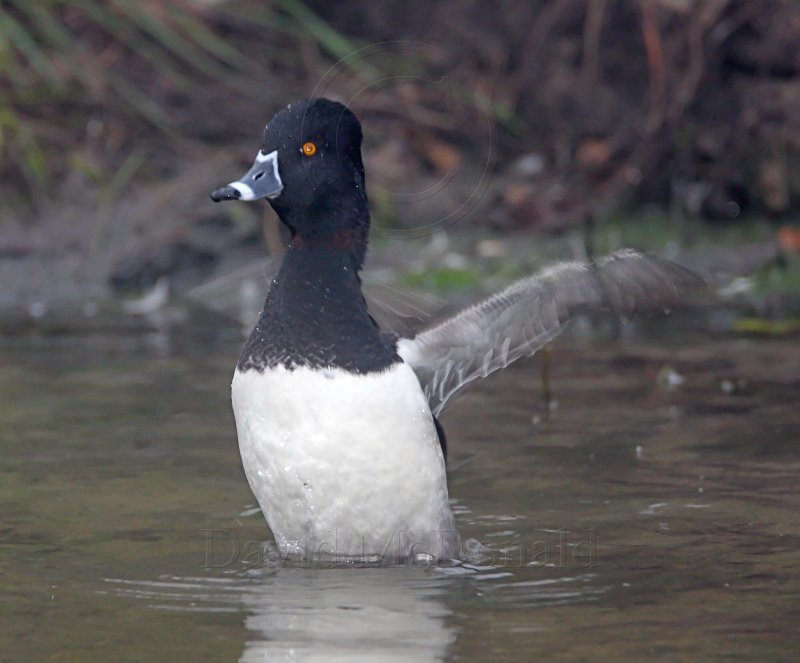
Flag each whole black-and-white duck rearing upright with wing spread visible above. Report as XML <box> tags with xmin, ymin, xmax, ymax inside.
<box><xmin>210</xmin><ymin>98</ymin><xmax>699</xmax><ymax>562</ymax></box>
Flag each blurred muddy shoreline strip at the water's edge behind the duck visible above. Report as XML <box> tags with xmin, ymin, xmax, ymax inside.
<box><xmin>0</xmin><ymin>211</ymin><xmax>800</xmax><ymax>342</ymax></box>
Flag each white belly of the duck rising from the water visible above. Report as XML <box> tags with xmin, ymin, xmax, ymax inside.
<box><xmin>232</xmin><ymin>363</ymin><xmax>459</xmax><ymax>559</ymax></box>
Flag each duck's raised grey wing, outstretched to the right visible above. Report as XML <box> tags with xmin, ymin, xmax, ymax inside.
<box><xmin>397</xmin><ymin>249</ymin><xmax>702</xmax><ymax>415</ymax></box>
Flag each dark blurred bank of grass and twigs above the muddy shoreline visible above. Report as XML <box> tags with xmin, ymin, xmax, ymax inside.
<box><xmin>0</xmin><ymin>0</ymin><xmax>800</xmax><ymax>316</ymax></box>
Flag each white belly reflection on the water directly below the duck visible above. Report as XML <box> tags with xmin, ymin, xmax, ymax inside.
<box><xmin>241</xmin><ymin>568</ymin><xmax>455</xmax><ymax>661</ymax></box>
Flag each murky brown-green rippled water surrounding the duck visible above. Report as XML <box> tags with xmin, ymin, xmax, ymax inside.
<box><xmin>0</xmin><ymin>319</ymin><xmax>800</xmax><ymax>661</ymax></box>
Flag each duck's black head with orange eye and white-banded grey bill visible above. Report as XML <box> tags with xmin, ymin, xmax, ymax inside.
<box><xmin>211</xmin><ymin>99</ymin><xmax>369</xmax><ymax>239</ymax></box>
